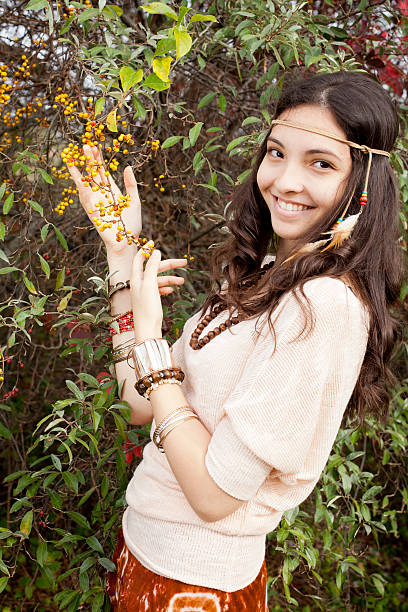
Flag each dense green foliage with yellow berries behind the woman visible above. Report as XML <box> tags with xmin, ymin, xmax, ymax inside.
<box><xmin>0</xmin><ymin>0</ymin><xmax>408</xmax><ymax>612</ymax></box>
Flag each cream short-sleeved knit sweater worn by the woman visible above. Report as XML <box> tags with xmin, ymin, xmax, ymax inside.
<box><xmin>123</xmin><ymin>277</ymin><xmax>368</xmax><ymax>591</ymax></box>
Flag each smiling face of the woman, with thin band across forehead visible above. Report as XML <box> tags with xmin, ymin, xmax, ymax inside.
<box><xmin>257</xmin><ymin>105</ymin><xmax>352</xmax><ymax>260</ymax></box>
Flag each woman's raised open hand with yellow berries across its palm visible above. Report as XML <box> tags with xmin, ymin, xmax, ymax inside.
<box><xmin>68</xmin><ymin>145</ymin><xmax>142</xmax><ymax>254</ymax></box>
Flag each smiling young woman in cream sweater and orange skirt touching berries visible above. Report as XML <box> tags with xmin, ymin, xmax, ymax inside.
<box><xmin>71</xmin><ymin>72</ymin><xmax>402</xmax><ymax>612</ymax></box>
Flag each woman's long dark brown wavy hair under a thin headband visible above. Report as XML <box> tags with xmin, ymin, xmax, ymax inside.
<box><xmin>201</xmin><ymin>72</ymin><xmax>403</xmax><ymax>422</ymax></box>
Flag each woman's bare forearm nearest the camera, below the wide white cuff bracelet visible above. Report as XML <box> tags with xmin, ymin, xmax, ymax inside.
<box><xmin>150</xmin><ymin>384</ymin><xmax>242</xmax><ymax>522</ymax></box>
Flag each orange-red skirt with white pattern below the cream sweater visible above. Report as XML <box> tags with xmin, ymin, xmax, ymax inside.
<box><xmin>107</xmin><ymin>530</ymin><xmax>268</xmax><ymax>612</ymax></box>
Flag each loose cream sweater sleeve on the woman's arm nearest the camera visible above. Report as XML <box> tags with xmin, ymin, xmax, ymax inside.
<box><xmin>205</xmin><ymin>278</ymin><xmax>367</xmax><ymax>502</ymax></box>
